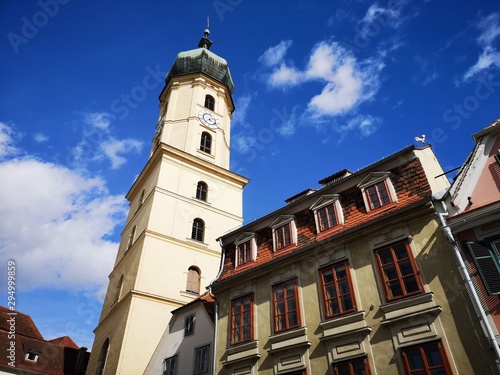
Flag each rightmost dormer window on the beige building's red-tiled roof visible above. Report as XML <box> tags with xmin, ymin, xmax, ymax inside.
<box><xmin>358</xmin><ymin>172</ymin><xmax>397</xmax><ymax>212</ymax></box>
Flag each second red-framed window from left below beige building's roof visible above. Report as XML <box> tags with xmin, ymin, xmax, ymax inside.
<box><xmin>273</xmin><ymin>279</ymin><xmax>300</xmax><ymax>332</ymax></box>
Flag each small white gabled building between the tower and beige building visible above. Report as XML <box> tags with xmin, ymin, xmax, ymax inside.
<box><xmin>144</xmin><ymin>292</ymin><xmax>215</xmax><ymax>375</ymax></box>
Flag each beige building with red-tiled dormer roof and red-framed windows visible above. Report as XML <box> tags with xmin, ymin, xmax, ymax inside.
<box><xmin>211</xmin><ymin>146</ymin><xmax>496</xmax><ymax>375</ymax></box>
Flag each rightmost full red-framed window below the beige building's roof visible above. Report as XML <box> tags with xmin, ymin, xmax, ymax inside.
<box><xmin>375</xmin><ymin>241</ymin><xmax>422</xmax><ymax>301</ymax></box>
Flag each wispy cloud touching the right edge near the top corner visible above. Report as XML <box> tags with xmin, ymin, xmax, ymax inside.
<box><xmin>464</xmin><ymin>13</ymin><xmax>500</xmax><ymax>80</ymax></box>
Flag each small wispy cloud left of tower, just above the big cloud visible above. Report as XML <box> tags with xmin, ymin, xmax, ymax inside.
<box><xmin>70</xmin><ymin>112</ymin><xmax>144</xmax><ymax>169</ymax></box>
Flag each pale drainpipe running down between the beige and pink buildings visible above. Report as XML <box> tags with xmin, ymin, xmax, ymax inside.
<box><xmin>436</xmin><ymin>201</ymin><xmax>500</xmax><ymax>371</ymax></box>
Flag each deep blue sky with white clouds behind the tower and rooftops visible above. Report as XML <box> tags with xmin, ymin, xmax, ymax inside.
<box><xmin>0</xmin><ymin>0</ymin><xmax>500</xmax><ymax>347</ymax></box>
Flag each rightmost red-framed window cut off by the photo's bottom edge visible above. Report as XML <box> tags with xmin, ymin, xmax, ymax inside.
<box><xmin>401</xmin><ymin>341</ymin><xmax>452</xmax><ymax>375</ymax></box>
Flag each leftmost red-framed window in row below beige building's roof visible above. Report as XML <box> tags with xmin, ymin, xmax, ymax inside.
<box><xmin>231</xmin><ymin>295</ymin><xmax>253</xmax><ymax>345</ymax></box>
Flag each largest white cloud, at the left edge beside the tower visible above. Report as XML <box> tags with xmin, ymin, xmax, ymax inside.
<box><xmin>0</xmin><ymin>127</ymin><xmax>127</xmax><ymax>293</ymax></box>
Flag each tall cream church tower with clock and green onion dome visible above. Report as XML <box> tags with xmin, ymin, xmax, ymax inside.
<box><xmin>87</xmin><ymin>29</ymin><xmax>248</xmax><ymax>375</ymax></box>
